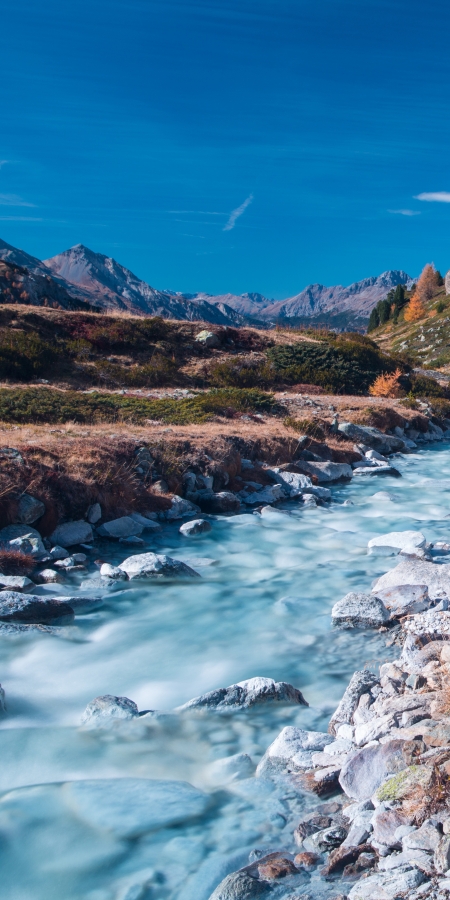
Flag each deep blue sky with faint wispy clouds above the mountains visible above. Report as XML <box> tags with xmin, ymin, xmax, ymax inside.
<box><xmin>0</xmin><ymin>0</ymin><xmax>450</xmax><ymax>299</ymax></box>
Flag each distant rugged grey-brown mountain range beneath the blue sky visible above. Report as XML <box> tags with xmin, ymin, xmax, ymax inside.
<box><xmin>0</xmin><ymin>240</ymin><xmax>412</xmax><ymax>327</ymax></box>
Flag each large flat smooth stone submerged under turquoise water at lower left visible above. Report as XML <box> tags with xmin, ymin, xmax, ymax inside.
<box><xmin>62</xmin><ymin>778</ymin><xmax>209</xmax><ymax>838</ymax></box>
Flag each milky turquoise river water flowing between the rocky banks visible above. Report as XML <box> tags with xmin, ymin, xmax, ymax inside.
<box><xmin>0</xmin><ymin>444</ymin><xmax>450</xmax><ymax>900</ymax></box>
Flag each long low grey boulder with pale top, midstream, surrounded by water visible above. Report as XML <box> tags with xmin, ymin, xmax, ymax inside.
<box><xmin>177</xmin><ymin>677</ymin><xmax>308</xmax><ymax>712</ymax></box>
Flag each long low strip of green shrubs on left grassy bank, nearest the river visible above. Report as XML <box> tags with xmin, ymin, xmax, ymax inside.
<box><xmin>0</xmin><ymin>388</ymin><xmax>275</xmax><ymax>425</ymax></box>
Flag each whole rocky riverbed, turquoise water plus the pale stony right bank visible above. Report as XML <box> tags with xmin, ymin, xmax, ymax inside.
<box><xmin>0</xmin><ymin>423</ymin><xmax>450</xmax><ymax>900</ymax></box>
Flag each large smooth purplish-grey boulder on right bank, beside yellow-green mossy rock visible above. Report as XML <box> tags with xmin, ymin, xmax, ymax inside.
<box><xmin>339</xmin><ymin>740</ymin><xmax>406</xmax><ymax>801</ymax></box>
